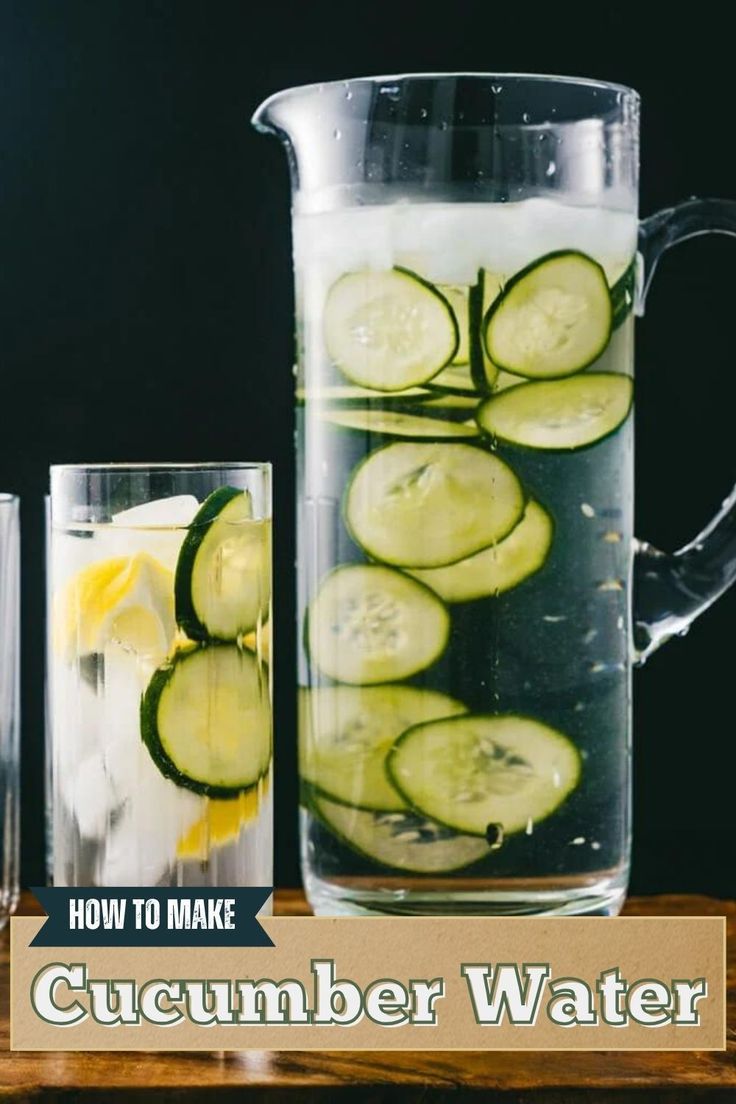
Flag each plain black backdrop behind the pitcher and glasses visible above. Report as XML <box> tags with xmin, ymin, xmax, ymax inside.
<box><xmin>0</xmin><ymin>0</ymin><xmax>736</xmax><ymax>895</ymax></box>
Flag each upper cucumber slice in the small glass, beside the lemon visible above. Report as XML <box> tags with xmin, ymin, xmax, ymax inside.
<box><xmin>174</xmin><ymin>487</ymin><xmax>270</xmax><ymax>641</ymax></box>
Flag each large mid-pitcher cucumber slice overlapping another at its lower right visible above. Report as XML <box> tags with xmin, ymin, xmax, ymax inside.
<box><xmin>345</xmin><ymin>442</ymin><xmax>524</xmax><ymax>567</ymax></box>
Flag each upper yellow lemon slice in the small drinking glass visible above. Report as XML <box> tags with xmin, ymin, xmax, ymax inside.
<box><xmin>54</xmin><ymin>552</ymin><xmax>175</xmax><ymax>660</ymax></box>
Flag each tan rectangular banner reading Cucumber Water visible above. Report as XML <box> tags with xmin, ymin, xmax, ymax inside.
<box><xmin>11</xmin><ymin>917</ymin><xmax>725</xmax><ymax>1050</ymax></box>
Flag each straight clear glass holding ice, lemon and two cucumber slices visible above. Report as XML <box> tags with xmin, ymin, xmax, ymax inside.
<box><xmin>47</xmin><ymin>464</ymin><xmax>273</xmax><ymax>885</ymax></box>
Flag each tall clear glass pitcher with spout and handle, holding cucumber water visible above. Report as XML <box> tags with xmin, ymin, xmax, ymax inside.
<box><xmin>254</xmin><ymin>74</ymin><xmax>736</xmax><ymax>915</ymax></box>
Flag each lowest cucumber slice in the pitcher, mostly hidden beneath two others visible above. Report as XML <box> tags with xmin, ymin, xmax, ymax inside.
<box><xmin>313</xmin><ymin>797</ymin><xmax>491</xmax><ymax>874</ymax></box>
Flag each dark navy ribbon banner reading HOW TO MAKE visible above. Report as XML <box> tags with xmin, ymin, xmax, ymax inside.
<box><xmin>31</xmin><ymin>885</ymin><xmax>274</xmax><ymax>947</ymax></box>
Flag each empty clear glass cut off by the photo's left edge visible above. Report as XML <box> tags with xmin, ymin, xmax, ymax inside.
<box><xmin>0</xmin><ymin>495</ymin><xmax>20</xmax><ymax>927</ymax></box>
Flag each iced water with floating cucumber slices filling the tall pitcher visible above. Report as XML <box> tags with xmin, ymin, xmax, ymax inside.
<box><xmin>295</xmin><ymin>199</ymin><xmax>637</xmax><ymax>914</ymax></box>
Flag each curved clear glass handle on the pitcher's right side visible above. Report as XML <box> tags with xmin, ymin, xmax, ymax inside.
<box><xmin>633</xmin><ymin>199</ymin><xmax>736</xmax><ymax>664</ymax></box>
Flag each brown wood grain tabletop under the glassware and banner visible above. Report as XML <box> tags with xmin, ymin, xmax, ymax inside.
<box><xmin>0</xmin><ymin>890</ymin><xmax>736</xmax><ymax>1104</ymax></box>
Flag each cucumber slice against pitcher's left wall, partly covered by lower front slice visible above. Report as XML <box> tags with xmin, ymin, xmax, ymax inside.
<box><xmin>299</xmin><ymin>684</ymin><xmax>467</xmax><ymax>811</ymax></box>
